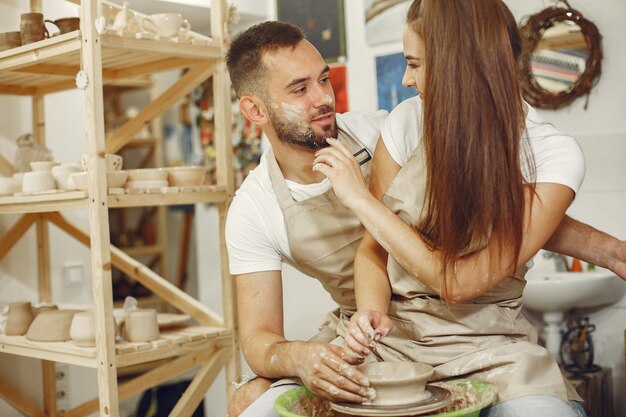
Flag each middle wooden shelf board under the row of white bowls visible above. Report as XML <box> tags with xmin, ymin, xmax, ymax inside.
<box><xmin>0</xmin><ymin>186</ymin><xmax>228</xmax><ymax>214</ymax></box>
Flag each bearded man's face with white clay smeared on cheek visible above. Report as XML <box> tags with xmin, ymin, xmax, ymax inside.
<box><xmin>264</xmin><ymin>40</ymin><xmax>337</xmax><ymax>149</ymax></box>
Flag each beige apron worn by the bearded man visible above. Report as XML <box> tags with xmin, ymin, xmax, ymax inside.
<box><xmin>268</xmin><ymin>129</ymin><xmax>371</xmax><ymax>343</ymax></box>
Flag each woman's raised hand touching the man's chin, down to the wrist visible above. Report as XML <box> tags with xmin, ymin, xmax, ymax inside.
<box><xmin>313</xmin><ymin>138</ymin><xmax>372</xmax><ymax>209</ymax></box>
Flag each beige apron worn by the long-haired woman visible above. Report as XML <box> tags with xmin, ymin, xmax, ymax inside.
<box><xmin>338</xmin><ymin>142</ymin><xmax>580</xmax><ymax>401</ymax></box>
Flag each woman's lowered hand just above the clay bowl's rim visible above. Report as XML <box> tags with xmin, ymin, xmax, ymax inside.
<box><xmin>344</xmin><ymin>310</ymin><xmax>393</xmax><ymax>364</ymax></box>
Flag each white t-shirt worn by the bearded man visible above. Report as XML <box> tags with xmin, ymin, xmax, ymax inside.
<box><xmin>226</xmin><ymin>110</ymin><xmax>388</xmax><ymax>275</ymax></box>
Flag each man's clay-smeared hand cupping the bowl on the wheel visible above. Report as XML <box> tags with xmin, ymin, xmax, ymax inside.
<box><xmin>294</xmin><ymin>343</ymin><xmax>373</xmax><ymax>403</ymax></box>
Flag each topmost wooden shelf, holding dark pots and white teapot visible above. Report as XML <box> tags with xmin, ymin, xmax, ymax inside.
<box><xmin>0</xmin><ymin>31</ymin><xmax>222</xmax><ymax>95</ymax></box>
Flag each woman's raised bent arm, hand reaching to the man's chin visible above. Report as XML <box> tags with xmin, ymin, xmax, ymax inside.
<box><xmin>314</xmin><ymin>140</ymin><xmax>574</xmax><ymax>302</ymax></box>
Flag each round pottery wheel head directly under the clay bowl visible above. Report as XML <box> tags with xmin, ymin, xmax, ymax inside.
<box><xmin>330</xmin><ymin>385</ymin><xmax>452</xmax><ymax>417</ymax></box>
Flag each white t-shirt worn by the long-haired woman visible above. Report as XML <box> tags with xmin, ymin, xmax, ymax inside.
<box><xmin>380</xmin><ymin>96</ymin><xmax>585</xmax><ymax>193</ymax></box>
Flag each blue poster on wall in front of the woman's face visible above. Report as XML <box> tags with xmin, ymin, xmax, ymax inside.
<box><xmin>376</xmin><ymin>52</ymin><xmax>417</xmax><ymax>111</ymax></box>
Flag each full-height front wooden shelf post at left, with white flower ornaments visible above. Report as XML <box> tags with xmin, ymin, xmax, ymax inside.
<box><xmin>80</xmin><ymin>0</ymin><xmax>119</xmax><ymax>417</ymax></box>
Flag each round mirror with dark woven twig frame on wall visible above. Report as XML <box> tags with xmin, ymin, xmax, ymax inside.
<box><xmin>520</xmin><ymin>1</ymin><xmax>602</xmax><ymax>109</ymax></box>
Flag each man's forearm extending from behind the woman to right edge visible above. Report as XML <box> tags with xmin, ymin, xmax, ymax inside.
<box><xmin>543</xmin><ymin>216</ymin><xmax>626</xmax><ymax>280</ymax></box>
